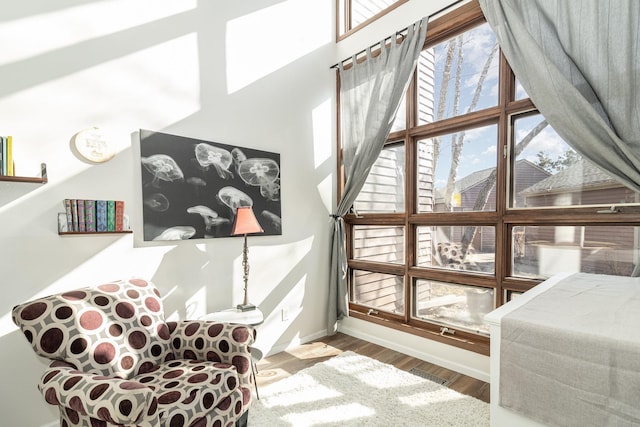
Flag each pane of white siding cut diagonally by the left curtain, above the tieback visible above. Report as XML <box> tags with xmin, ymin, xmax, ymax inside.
<box><xmin>353</xmin><ymin>144</ymin><xmax>405</xmax><ymax>213</ymax></box>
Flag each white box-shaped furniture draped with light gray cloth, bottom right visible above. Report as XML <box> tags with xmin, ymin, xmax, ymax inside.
<box><xmin>499</xmin><ymin>273</ymin><xmax>640</xmax><ymax>427</ymax></box>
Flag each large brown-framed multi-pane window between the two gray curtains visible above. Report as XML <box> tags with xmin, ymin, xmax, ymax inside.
<box><xmin>338</xmin><ymin>1</ymin><xmax>640</xmax><ymax>354</ymax></box>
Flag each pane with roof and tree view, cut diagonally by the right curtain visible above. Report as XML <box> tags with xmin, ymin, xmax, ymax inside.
<box><xmin>510</xmin><ymin>114</ymin><xmax>640</xmax><ymax>208</ymax></box>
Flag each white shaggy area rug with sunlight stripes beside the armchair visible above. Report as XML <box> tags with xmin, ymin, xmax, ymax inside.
<box><xmin>249</xmin><ymin>351</ymin><xmax>489</xmax><ymax>427</ymax></box>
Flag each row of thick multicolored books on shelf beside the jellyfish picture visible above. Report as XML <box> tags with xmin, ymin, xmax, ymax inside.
<box><xmin>64</xmin><ymin>199</ymin><xmax>128</xmax><ymax>232</ymax></box>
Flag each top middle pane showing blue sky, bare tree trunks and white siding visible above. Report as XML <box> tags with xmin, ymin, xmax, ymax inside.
<box><xmin>417</xmin><ymin>24</ymin><xmax>498</xmax><ymax>125</ymax></box>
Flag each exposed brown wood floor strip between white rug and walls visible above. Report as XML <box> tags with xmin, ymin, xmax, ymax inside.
<box><xmin>256</xmin><ymin>333</ymin><xmax>489</xmax><ymax>403</ymax></box>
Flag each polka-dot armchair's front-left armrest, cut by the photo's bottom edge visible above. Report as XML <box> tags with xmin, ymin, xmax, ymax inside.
<box><xmin>38</xmin><ymin>361</ymin><xmax>159</xmax><ymax>425</ymax></box>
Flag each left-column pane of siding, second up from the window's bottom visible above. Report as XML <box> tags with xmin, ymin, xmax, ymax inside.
<box><xmin>353</xmin><ymin>225</ymin><xmax>404</xmax><ymax>264</ymax></box>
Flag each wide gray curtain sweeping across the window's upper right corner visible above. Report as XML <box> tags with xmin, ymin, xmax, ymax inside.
<box><xmin>480</xmin><ymin>0</ymin><xmax>640</xmax><ymax>191</ymax></box>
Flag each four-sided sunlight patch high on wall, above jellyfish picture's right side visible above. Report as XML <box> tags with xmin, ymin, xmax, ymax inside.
<box><xmin>226</xmin><ymin>0</ymin><xmax>333</xmax><ymax>94</ymax></box>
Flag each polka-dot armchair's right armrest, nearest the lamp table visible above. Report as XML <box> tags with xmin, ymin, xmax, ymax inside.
<box><xmin>167</xmin><ymin>320</ymin><xmax>256</xmax><ymax>387</ymax></box>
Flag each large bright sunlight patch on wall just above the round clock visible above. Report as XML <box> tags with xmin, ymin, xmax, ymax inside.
<box><xmin>0</xmin><ymin>33</ymin><xmax>200</xmax><ymax>174</ymax></box>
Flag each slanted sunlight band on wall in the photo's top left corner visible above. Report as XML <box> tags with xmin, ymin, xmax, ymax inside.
<box><xmin>0</xmin><ymin>0</ymin><xmax>197</xmax><ymax>65</ymax></box>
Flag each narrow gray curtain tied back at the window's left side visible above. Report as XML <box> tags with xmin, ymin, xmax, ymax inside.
<box><xmin>327</xmin><ymin>18</ymin><xmax>427</xmax><ymax>334</ymax></box>
